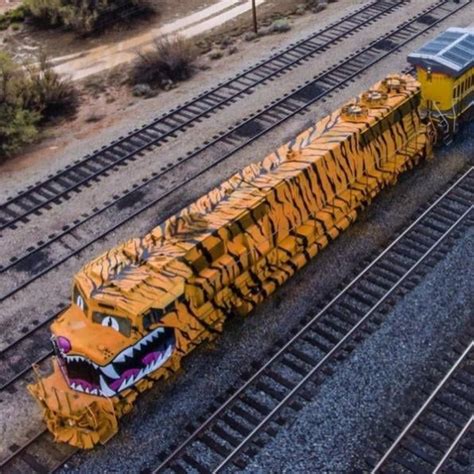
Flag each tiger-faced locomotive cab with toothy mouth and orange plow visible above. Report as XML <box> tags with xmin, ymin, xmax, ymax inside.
<box><xmin>28</xmin><ymin>252</ymin><xmax>189</xmax><ymax>448</ymax></box>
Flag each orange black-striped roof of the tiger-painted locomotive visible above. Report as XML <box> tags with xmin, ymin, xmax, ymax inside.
<box><xmin>75</xmin><ymin>76</ymin><xmax>418</xmax><ymax>314</ymax></box>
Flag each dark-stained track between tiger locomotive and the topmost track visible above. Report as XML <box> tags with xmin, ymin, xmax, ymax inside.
<box><xmin>0</xmin><ymin>0</ymin><xmax>471</xmax><ymax>303</ymax></box>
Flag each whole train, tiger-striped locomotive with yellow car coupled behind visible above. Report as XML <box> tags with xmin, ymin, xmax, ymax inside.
<box><xmin>28</xmin><ymin>29</ymin><xmax>473</xmax><ymax>449</ymax></box>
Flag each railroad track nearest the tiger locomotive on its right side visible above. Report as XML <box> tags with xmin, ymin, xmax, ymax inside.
<box><xmin>150</xmin><ymin>168</ymin><xmax>474</xmax><ymax>473</ymax></box>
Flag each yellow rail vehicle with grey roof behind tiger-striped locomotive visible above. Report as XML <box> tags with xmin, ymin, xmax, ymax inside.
<box><xmin>408</xmin><ymin>27</ymin><xmax>474</xmax><ymax>143</ymax></box>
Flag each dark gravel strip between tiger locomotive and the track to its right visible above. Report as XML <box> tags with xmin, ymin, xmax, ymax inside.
<box><xmin>63</xmin><ymin>125</ymin><xmax>474</xmax><ymax>473</ymax></box>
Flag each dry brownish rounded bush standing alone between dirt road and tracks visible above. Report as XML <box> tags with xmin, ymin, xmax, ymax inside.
<box><xmin>131</xmin><ymin>36</ymin><xmax>196</xmax><ymax>85</ymax></box>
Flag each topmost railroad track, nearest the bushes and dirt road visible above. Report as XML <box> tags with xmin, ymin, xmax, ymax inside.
<box><xmin>0</xmin><ymin>0</ymin><xmax>409</xmax><ymax>231</ymax></box>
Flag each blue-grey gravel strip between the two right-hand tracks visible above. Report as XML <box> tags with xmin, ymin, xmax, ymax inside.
<box><xmin>245</xmin><ymin>227</ymin><xmax>474</xmax><ymax>473</ymax></box>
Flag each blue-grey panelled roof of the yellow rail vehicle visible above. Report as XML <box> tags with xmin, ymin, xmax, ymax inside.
<box><xmin>408</xmin><ymin>27</ymin><xmax>474</xmax><ymax>77</ymax></box>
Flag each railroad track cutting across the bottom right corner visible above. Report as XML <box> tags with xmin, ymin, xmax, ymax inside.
<box><xmin>369</xmin><ymin>338</ymin><xmax>474</xmax><ymax>474</ymax></box>
